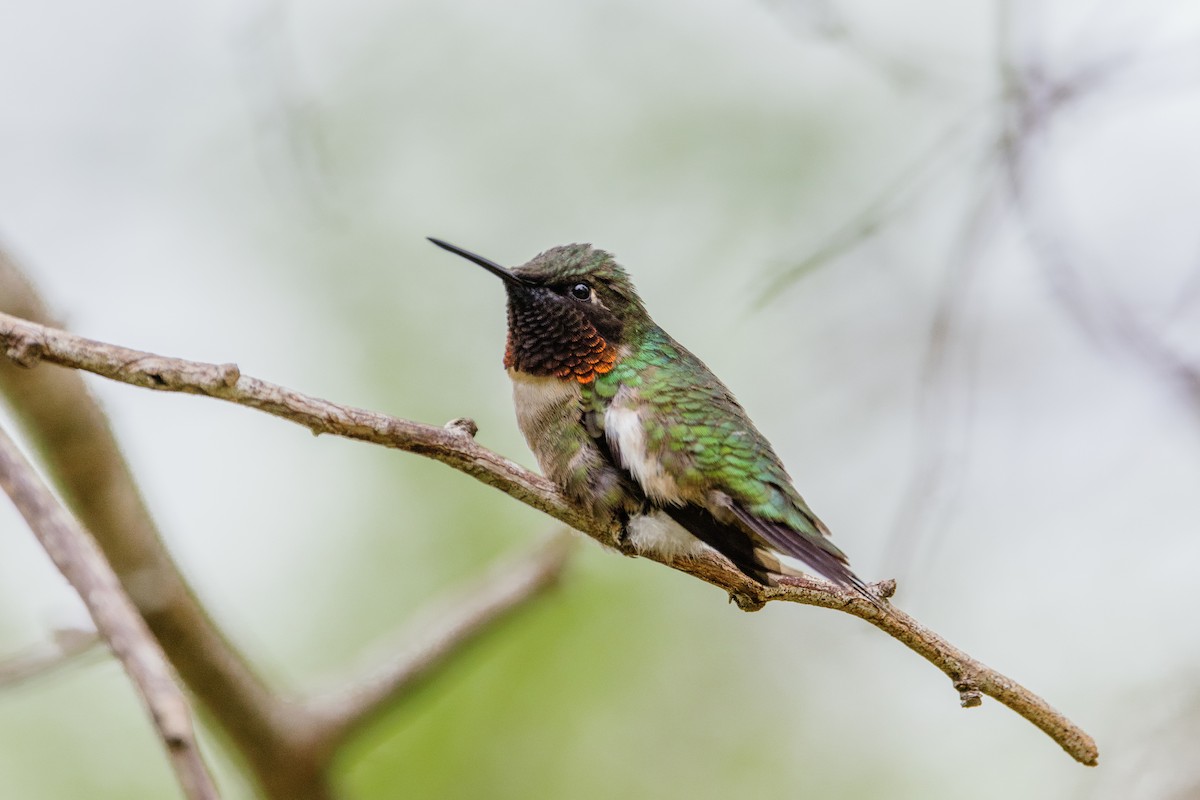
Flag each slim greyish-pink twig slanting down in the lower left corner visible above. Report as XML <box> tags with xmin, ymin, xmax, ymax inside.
<box><xmin>0</xmin><ymin>428</ymin><xmax>220</xmax><ymax>800</ymax></box>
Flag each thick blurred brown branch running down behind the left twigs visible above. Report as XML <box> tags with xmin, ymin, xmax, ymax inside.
<box><xmin>0</xmin><ymin>251</ymin><xmax>322</xmax><ymax>798</ymax></box>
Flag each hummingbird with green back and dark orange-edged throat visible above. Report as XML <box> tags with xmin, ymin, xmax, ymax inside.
<box><xmin>430</xmin><ymin>237</ymin><xmax>880</xmax><ymax>604</ymax></box>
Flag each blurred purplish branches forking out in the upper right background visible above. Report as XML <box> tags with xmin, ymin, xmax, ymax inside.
<box><xmin>758</xmin><ymin>0</ymin><xmax>1200</xmax><ymax>576</ymax></box>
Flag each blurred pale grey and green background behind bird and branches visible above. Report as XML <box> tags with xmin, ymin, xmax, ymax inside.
<box><xmin>0</xmin><ymin>0</ymin><xmax>1200</xmax><ymax>800</ymax></box>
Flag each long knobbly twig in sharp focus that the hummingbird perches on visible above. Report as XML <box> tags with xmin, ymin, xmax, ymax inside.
<box><xmin>0</xmin><ymin>314</ymin><xmax>1098</xmax><ymax>765</ymax></box>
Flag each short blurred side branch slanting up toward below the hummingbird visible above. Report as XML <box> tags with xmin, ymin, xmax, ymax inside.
<box><xmin>308</xmin><ymin>533</ymin><xmax>575</xmax><ymax>754</ymax></box>
